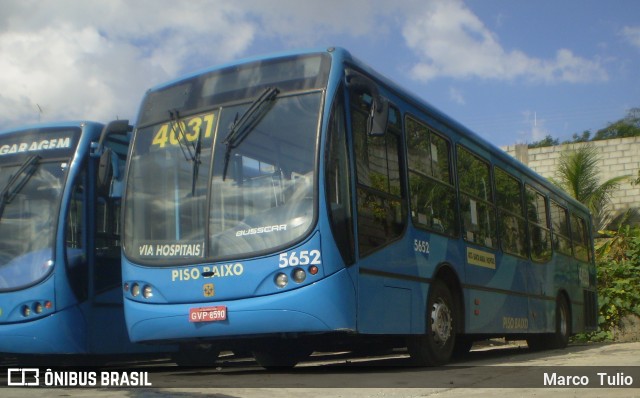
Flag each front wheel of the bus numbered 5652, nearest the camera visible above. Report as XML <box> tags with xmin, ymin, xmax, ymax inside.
<box><xmin>407</xmin><ymin>280</ymin><xmax>458</xmax><ymax>366</ymax></box>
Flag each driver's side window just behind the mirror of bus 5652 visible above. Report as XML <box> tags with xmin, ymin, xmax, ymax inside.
<box><xmin>351</xmin><ymin>93</ymin><xmax>404</xmax><ymax>255</ymax></box>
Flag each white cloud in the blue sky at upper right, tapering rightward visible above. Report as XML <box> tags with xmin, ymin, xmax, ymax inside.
<box><xmin>403</xmin><ymin>1</ymin><xmax>608</xmax><ymax>83</ymax></box>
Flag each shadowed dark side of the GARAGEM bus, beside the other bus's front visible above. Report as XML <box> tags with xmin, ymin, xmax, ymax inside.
<box><xmin>85</xmin><ymin>121</ymin><xmax>133</xmax><ymax>354</ymax></box>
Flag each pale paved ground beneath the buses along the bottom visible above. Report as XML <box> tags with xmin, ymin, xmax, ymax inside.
<box><xmin>0</xmin><ymin>343</ymin><xmax>640</xmax><ymax>398</ymax></box>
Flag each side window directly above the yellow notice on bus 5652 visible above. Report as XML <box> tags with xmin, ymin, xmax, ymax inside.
<box><xmin>457</xmin><ymin>146</ymin><xmax>497</xmax><ymax>249</ymax></box>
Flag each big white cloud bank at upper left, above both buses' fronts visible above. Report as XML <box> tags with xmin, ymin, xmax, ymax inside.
<box><xmin>0</xmin><ymin>0</ymin><xmax>403</xmax><ymax>127</ymax></box>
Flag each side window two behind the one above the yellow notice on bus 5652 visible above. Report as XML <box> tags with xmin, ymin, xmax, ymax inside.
<box><xmin>526</xmin><ymin>186</ymin><xmax>552</xmax><ymax>263</ymax></box>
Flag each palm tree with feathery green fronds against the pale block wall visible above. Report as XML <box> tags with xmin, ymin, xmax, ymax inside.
<box><xmin>551</xmin><ymin>144</ymin><xmax>629</xmax><ymax>232</ymax></box>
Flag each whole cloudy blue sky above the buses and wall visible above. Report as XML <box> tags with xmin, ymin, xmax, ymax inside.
<box><xmin>0</xmin><ymin>0</ymin><xmax>640</xmax><ymax>146</ymax></box>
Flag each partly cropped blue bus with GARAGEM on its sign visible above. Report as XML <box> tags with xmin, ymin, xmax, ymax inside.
<box><xmin>0</xmin><ymin>121</ymin><xmax>162</xmax><ymax>358</ymax></box>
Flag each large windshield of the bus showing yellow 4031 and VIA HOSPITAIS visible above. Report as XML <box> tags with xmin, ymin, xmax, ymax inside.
<box><xmin>124</xmin><ymin>56</ymin><xmax>327</xmax><ymax>265</ymax></box>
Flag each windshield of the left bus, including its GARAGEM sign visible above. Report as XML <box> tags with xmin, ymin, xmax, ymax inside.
<box><xmin>0</xmin><ymin>130</ymin><xmax>79</xmax><ymax>290</ymax></box>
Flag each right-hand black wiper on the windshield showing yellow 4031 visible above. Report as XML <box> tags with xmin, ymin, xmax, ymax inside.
<box><xmin>222</xmin><ymin>87</ymin><xmax>280</xmax><ymax>181</ymax></box>
